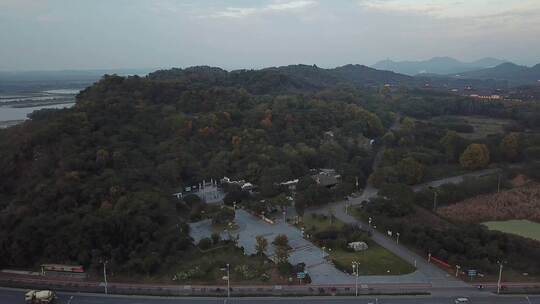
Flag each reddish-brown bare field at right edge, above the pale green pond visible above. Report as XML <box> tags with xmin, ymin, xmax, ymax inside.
<box><xmin>437</xmin><ymin>183</ymin><xmax>540</xmax><ymax>223</ymax></box>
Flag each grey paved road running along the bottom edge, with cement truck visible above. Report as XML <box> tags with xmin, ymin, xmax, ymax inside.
<box><xmin>0</xmin><ymin>288</ymin><xmax>540</xmax><ymax>304</ymax></box>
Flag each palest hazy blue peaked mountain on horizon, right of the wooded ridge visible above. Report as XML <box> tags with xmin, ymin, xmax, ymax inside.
<box><xmin>371</xmin><ymin>57</ymin><xmax>506</xmax><ymax>76</ymax></box>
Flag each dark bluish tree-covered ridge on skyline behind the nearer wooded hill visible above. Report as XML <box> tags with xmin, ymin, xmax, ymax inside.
<box><xmin>148</xmin><ymin>65</ymin><xmax>416</xmax><ymax>94</ymax></box>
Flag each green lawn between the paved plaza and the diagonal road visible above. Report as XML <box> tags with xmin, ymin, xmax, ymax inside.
<box><xmin>330</xmin><ymin>242</ymin><xmax>415</xmax><ymax>275</ymax></box>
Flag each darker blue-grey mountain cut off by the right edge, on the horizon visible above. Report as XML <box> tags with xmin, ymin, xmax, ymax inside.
<box><xmin>452</xmin><ymin>62</ymin><xmax>540</xmax><ymax>86</ymax></box>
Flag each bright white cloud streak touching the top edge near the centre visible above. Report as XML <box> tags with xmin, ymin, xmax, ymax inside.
<box><xmin>202</xmin><ymin>0</ymin><xmax>316</xmax><ymax>18</ymax></box>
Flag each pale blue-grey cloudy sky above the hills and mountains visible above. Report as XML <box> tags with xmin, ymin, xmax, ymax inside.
<box><xmin>0</xmin><ymin>0</ymin><xmax>540</xmax><ymax>70</ymax></box>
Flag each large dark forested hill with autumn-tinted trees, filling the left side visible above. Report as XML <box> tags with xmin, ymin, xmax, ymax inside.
<box><xmin>0</xmin><ymin>67</ymin><xmax>392</xmax><ymax>273</ymax></box>
